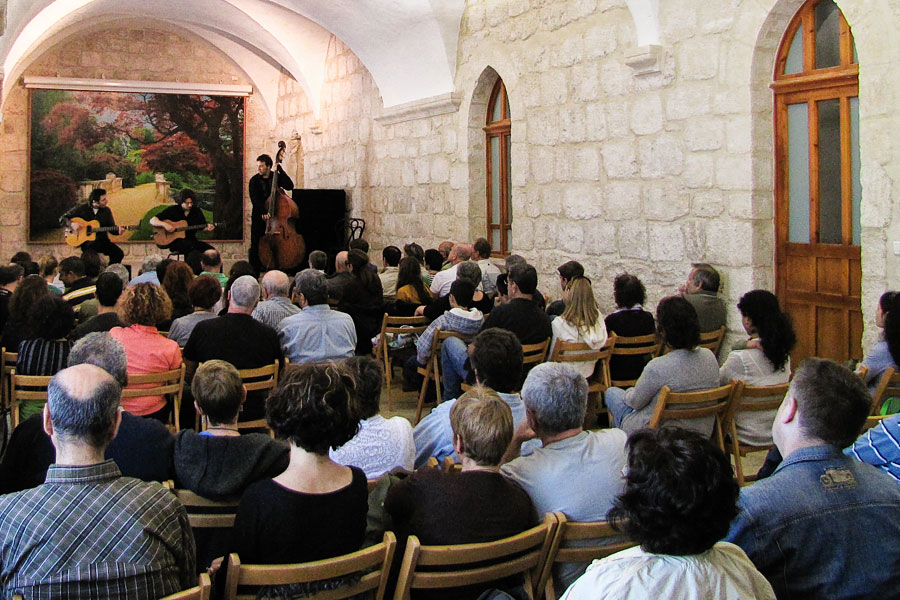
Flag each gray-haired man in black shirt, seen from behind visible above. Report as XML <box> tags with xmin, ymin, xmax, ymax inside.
<box><xmin>183</xmin><ymin>275</ymin><xmax>284</xmax><ymax>421</ymax></box>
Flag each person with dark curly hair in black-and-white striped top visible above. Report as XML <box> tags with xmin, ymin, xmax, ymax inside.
<box><xmin>16</xmin><ymin>295</ymin><xmax>75</xmax><ymax>422</ymax></box>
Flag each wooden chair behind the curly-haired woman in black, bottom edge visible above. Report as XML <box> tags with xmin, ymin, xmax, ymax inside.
<box><xmin>225</xmin><ymin>531</ymin><xmax>397</xmax><ymax>600</ymax></box>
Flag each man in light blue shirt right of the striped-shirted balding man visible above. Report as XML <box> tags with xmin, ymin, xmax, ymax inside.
<box><xmin>278</xmin><ymin>269</ymin><xmax>357</xmax><ymax>363</ymax></box>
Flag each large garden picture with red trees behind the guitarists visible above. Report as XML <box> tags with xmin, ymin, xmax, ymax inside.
<box><xmin>28</xmin><ymin>89</ymin><xmax>244</xmax><ymax>242</ymax></box>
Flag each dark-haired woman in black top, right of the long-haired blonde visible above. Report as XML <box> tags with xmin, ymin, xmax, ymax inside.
<box><xmin>605</xmin><ymin>273</ymin><xmax>656</xmax><ymax>381</ymax></box>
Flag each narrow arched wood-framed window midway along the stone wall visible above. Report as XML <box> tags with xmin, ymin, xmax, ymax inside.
<box><xmin>484</xmin><ymin>78</ymin><xmax>512</xmax><ymax>255</ymax></box>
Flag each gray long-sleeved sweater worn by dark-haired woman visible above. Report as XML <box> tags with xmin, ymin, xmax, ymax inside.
<box><xmin>621</xmin><ymin>347</ymin><xmax>719</xmax><ymax>435</ymax></box>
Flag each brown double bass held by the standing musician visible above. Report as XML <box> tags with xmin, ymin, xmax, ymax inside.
<box><xmin>259</xmin><ymin>141</ymin><xmax>306</xmax><ymax>271</ymax></box>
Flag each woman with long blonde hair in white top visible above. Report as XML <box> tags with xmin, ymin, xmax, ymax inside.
<box><xmin>549</xmin><ymin>277</ymin><xmax>608</xmax><ymax>377</ymax></box>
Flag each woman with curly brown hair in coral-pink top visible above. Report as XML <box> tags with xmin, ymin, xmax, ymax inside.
<box><xmin>109</xmin><ymin>283</ymin><xmax>181</xmax><ymax>423</ymax></box>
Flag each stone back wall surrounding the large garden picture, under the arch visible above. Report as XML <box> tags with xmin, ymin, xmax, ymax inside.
<box><xmin>0</xmin><ymin>24</ymin><xmax>269</xmax><ymax>273</ymax></box>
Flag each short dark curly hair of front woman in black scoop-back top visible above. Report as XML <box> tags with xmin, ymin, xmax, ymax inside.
<box><xmin>266</xmin><ymin>362</ymin><xmax>359</xmax><ymax>456</ymax></box>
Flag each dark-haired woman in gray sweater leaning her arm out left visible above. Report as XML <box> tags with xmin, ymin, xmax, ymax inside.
<box><xmin>604</xmin><ymin>296</ymin><xmax>719</xmax><ymax>434</ymax></box>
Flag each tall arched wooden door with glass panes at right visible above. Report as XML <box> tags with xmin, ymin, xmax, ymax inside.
<box><xmin>772</xmin><ymin>0</ymin><xmax>862</xmax><ymax>360</ymax></box>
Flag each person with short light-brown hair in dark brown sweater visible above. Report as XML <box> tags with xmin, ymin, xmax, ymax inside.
<box><xmin>384</xmin><ymin>384</ymin><xmax>537</xmax><ymax>600</ymax></box>
